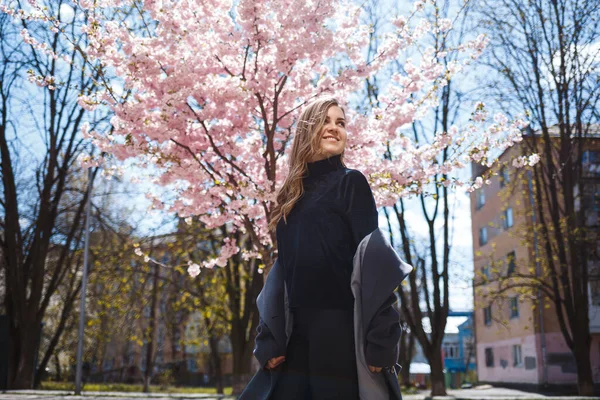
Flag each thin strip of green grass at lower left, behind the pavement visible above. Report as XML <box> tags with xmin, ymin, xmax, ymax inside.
<box><xmin>41</xmin><ymin>381</ymin><xmax>231</xmax><ymax>395</ymax></box>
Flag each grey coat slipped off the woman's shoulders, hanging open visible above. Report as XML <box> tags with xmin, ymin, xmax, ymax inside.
<box><xmin>238</xmin><ymin>228</ymin><xmax>413</xmax><ymax>400</ymax></box>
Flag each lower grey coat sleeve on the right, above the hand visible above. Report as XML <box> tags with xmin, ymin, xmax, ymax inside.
<box><xmin>365</xmin><ymin>293</ymin><xmax>402</xmax><ymax>367</ymax></box>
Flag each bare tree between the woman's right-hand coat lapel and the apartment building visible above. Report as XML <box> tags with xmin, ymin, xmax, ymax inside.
<box><xmin>366</xmin><ymin>0</ymin><xmax>478</xmax><ymax>396</ymax></box>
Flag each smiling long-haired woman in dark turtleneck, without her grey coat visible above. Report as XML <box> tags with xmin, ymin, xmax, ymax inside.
<box><xmin>241</xmin><ymin>98</ymin><xmax>401</xmax><ymax>400</ymax></box>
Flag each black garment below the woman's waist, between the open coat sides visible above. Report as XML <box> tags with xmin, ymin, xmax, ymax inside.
<box><xmin>270</xmin><ymin>308</ymin><xmax>359</xmax><ymax>400</ymax></box>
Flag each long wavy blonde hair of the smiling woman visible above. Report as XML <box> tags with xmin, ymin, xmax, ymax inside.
<box><xmin>269</xmin><ymin>97</ymin><xmax>346</xmax><ymax>231</ymax></box>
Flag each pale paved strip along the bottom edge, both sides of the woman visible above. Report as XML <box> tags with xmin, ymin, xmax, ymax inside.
<box><xmin>0</xmin><ymin>385</ymin><xmax>600</xmax><ymax>400</ymax></box>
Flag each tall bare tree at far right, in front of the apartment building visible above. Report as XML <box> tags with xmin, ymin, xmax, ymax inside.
<box><xmin>478</xmin><ymin>0</ymin><xmax>600</xmax><ymax>395</ymax></box>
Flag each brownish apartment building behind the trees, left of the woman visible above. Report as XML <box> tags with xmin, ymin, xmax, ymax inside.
<box><xmin>86</xmin><ymin>234</ymin><xmax>233</xmax><ymax>385</ymax></box>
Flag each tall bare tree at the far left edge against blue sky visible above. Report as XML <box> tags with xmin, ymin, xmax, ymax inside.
<box><xmin>0</xmin><ymin>1</ymin><xmax>112</xmax><ymax>389</ymax></box>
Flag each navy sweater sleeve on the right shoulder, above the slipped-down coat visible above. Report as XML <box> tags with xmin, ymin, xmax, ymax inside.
<box><xmin>342</xmin><ymin>170</ymin><xmax>379</xmax><ymax>247</ymax></box>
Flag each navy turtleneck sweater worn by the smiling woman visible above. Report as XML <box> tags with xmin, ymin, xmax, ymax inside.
<box><xmin>277</xmin><ymin>155</ymin><xmax>378</xmax><ymax>309</ymax></box>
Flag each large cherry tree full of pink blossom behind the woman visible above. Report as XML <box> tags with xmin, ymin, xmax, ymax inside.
<box><xmin>3</xmin><ymin>0</ymin><xmax>529</xmax><ymax>273</ymax></box>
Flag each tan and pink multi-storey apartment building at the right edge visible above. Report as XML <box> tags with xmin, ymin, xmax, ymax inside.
<box><xmin>470</xmin><ymin>127</ymin><xmax>600</xmax><ymax>386</ymax></box>
